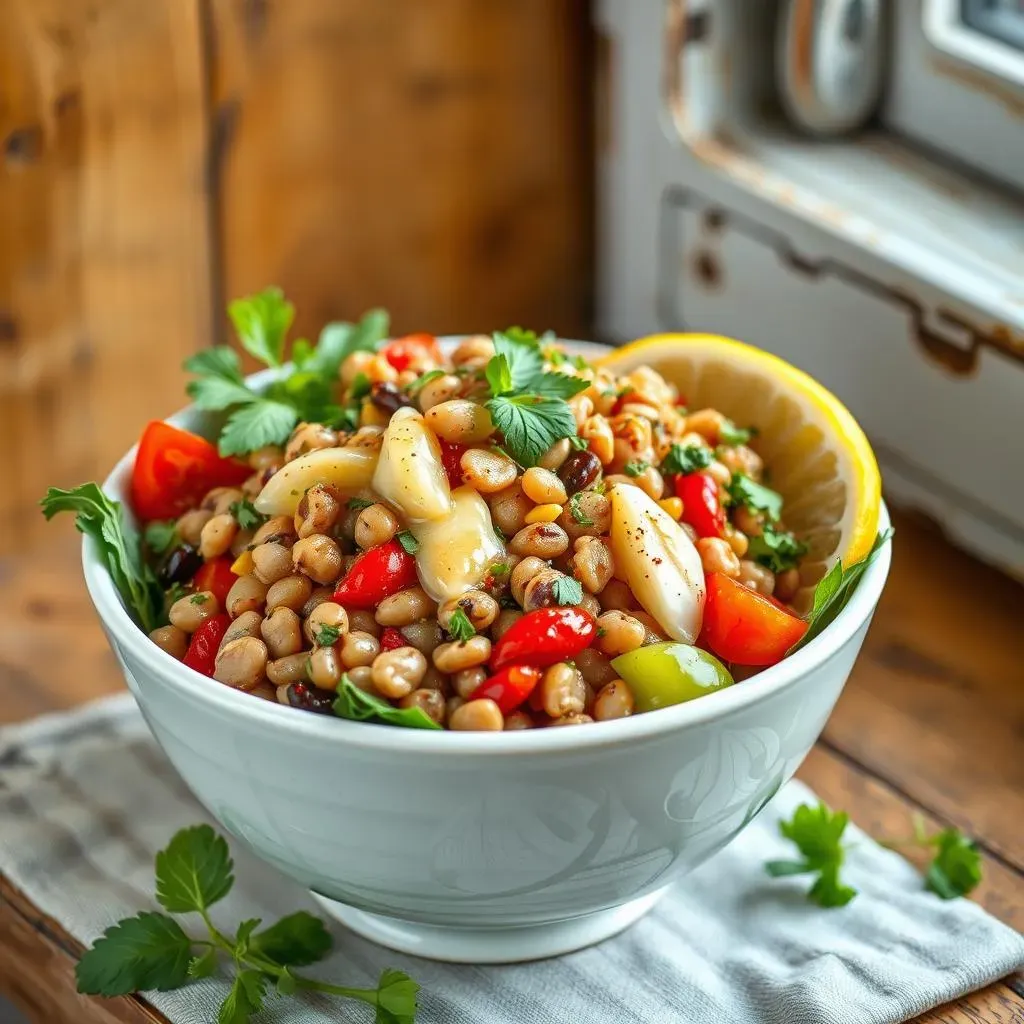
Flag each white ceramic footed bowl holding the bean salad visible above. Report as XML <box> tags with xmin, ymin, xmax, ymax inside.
<box><xmin>83</xmin><ymin>345</ymin><xmax>891</xmax><ymax>963</ymax></box>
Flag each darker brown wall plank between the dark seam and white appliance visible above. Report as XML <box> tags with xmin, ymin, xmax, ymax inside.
<box><xmin>209</xmin><ymin>0</ymin><xmax>592</xmax><ymax>344</ymax></box>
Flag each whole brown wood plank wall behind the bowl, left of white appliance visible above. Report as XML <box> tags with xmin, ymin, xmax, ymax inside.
<box><xmin>0</xmin><ymin>0</ymin><xmax>592</xmax><ymax>554</ymax></box>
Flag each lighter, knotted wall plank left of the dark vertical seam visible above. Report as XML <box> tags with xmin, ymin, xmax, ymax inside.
<box><xmin>0</xmin><ymin>0</ymin><xmax>211</xmax><ymax>552</ymax></box>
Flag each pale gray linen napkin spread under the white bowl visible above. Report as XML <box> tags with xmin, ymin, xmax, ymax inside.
<box><xmin>0</xmin><ymin>696</ymin><xmax>1024</xmax><ymax>1024</ymax></box>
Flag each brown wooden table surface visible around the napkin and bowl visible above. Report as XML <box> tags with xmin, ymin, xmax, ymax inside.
<box><xmin>0</xmin><ymin>516</ymin><xmax>1024</xmax><ymax>1024</ymax></box>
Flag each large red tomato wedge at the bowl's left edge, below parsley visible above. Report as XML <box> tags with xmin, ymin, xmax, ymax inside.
<box><xmin>131</xmin><ymin>420</ymin><xmax>253</xmax><ymax>521</ymax></box>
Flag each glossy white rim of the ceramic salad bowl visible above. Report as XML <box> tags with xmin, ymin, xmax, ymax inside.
<box><xmin>82</xmin><ymin>337</ymin><xmax>892</xmax><ymax>757</ymax></box>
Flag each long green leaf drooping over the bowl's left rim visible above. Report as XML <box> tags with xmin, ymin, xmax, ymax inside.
<box><xmin>39</xmin><ymin>483</ymin><xmax>166</xmax><ymax>633</ymax></box>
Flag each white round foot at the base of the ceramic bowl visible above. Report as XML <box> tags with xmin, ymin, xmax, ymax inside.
<box><xmin>313</xmin><ymin>889</ymin><xmax>665</xmax><ymax>964</ymax></box>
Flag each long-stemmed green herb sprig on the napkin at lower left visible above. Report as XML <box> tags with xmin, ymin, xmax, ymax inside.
<box><xmin>75</xmin><ymin>825</ymin><xmax>419</xmax><ymax>1024</ymax></box>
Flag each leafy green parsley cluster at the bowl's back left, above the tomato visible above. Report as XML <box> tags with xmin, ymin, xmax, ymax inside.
<box><xmin>184</xmin><ymin>288</ymin><xmax>388</xmax><ymax>456</ymax></box>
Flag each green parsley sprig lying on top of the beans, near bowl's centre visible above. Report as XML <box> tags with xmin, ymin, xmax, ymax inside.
<box><xmin>484</xmin><ymin>328</ymin><xmax>590</xmax><ymax>466</ymax></box>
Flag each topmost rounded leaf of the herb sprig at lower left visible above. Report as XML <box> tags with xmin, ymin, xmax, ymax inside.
<box><xmin>157</xmin><ymin>825</ymin><xmax>234</xmax><ymax>913</ymax></box>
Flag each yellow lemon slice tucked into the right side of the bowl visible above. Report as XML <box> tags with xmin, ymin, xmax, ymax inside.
<box><xmin>597</xmin><ymin>334</ymin><xmax>882</xmax><ymax>610</ymax></box>
